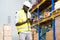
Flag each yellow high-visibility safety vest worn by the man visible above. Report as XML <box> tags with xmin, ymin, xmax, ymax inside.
<box><xmin>16</xmin><ymin>9</ymin><xmax>31</xmax><ymax>32</ymax></box>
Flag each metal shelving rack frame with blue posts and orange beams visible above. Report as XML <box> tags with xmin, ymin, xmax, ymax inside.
<box><xmin>31</xmin><ymin>0</ymin><xmax>60</xmax><ymax>40</ymax></box>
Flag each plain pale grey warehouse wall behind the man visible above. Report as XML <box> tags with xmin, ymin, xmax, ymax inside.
<box><xmin>0</xmin><ymin>0</ymin><xmax>25</xmax><ymax>40</ymax></box>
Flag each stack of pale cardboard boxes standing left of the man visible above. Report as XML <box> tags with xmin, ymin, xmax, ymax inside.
<box><xmin>4</xmin><ymin>24</ymin><xmax>12</xmax><ymax>40</ymax></box>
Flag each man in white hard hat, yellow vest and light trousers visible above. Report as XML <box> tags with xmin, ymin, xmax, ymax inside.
<box><xmin>16</xmin><ymin>1</ymin><xmax>32</xmax><ymax>40</ymax></box>
